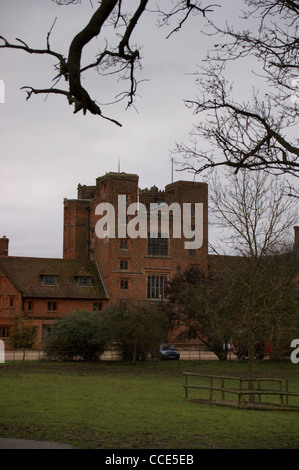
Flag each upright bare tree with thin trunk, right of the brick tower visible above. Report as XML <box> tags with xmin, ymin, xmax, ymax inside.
<box><xmin>210</xmin><ymin>170</ymin><xmax>298</xmax><ymax>386</ymax></box>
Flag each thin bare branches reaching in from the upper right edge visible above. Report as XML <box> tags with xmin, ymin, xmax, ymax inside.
<box><xmin>175</xmin><ymin>0</ymin><xmax>299</xmax><ymax>180</ymax></box>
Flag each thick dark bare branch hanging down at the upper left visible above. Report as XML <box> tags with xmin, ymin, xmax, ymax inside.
<box><xmin>0</xmin><ymin>0</ymin><xmax>218</xmax><ymax>125</ymax></box>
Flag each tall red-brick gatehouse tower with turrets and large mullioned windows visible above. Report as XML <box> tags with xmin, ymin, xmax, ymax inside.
<box><xmin>63</xmin><ymin>173</ymin><xmax>208</xmax><ymax>302</ymax></box>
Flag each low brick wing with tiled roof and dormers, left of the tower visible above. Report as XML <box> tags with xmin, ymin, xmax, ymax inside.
<box><xmin>0</xmin><ymin>255</ymin><xmax>108</xmax><ymax>349</ymax></box>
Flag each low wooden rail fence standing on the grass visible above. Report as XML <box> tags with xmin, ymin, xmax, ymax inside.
<box><xmin>183</xmin><ymin>372</ymin><xmax>299</xmax><ymax>410</ymax></box>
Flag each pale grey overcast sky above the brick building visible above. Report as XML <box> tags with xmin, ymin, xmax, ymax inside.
<box><xmin>0</xmin><ymin>0</ymin><xmax>298</xmax><ymax>257</ymax></box>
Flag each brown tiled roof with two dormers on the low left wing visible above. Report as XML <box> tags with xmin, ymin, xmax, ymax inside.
<box><xmin>0</xmin><ymin>256</ymin><xmax>108</xmax><ymax>300</ymax></box>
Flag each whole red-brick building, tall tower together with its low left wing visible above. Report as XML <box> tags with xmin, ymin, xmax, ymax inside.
<box><xmin>0</xmin><ymin>173</ymin><xmax>208</xmax><ymax>348</ymax></box>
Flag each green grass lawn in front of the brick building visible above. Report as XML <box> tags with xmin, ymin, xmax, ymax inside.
<box><xmin>0</xmin><ymin>361</ymin><xmax>299</xmax><ymax>449</ymax></box>
